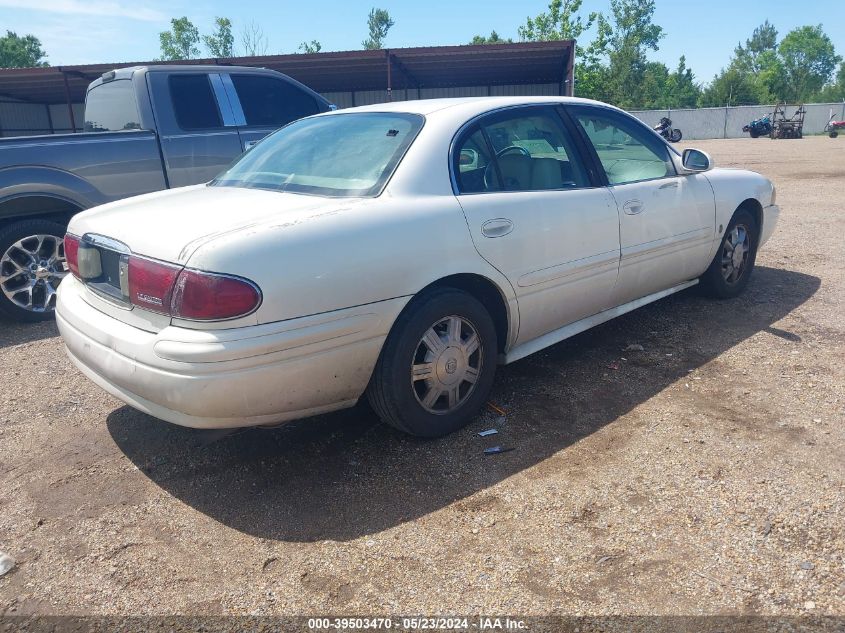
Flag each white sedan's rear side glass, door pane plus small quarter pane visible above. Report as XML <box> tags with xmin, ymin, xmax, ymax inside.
<box><xmin>453</xmin><ymin>108</ymin><xmax>590</xmax><ymax>193</ymax></box>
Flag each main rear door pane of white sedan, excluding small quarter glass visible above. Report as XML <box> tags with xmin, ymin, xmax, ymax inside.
<box><xmin>481</xmin><ymin>108</ymin><xmax>590</xmax><ymax>191</ymax></box>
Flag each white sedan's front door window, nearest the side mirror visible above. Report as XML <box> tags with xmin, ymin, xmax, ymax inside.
<box><xmin>573</xmin><ymin>109</ymin><xmax>675</xmax><ymax>185</ymax></box>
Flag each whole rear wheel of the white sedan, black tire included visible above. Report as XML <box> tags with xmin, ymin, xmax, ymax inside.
<box><xmin>367</xmin><ymin>288</ymin><xmax>498</xmax><ymax>437</ymax></box>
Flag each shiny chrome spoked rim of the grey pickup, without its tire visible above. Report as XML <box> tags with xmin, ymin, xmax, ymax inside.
<box><xmin>0</xmin><ymin>234</ymin><xmax>67</xmax><ymax>312</ymax></box>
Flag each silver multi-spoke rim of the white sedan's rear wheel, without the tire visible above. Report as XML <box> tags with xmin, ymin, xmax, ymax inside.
<box><xmin>411</xmin><ymin>316</ymin><xmax>484</xmax><ymax>415</ymax></box>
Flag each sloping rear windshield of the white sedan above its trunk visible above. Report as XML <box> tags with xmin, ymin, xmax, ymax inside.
<box><xmin>211</xmin><ymin>112</ymin><xmax>423</xmax><ymax>196</ymax></box>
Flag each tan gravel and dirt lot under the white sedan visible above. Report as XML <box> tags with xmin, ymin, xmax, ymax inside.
<box><xmin>0</xmin><ymin>137</ymin><xmax>845</xmax><ymax>615</ymax></box>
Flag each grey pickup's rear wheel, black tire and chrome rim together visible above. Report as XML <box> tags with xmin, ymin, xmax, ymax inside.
<box><xmin>0</xmin><ymin>220</ymin><xmax>67</xmax><ymax>322</ymax></box>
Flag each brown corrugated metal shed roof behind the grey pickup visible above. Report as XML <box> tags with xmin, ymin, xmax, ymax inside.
<box><xmin>0</xmin><ymin>40</ymin><xmax>574</xmax><ymax>103</ymax></box>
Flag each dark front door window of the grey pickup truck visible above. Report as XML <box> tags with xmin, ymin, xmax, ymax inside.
<box><xmin>227</xmin><ymin>75</ymin><xmax>320</xmax><ymax>127</ymax></box>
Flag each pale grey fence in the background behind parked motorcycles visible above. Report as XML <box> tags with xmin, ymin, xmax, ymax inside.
<box><xmin>631</xmin><ymin>102</ymin><xmax>845</xmax><ymax>140</ymax></box>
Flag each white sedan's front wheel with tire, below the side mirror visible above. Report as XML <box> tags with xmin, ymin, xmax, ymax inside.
<box><xmin>700</xmin><ymin>209</ymin><xmax>760</xmax><ymax>299</ymax></box>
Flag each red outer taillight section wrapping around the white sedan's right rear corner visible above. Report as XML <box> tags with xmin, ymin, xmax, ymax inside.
<box><xmin>171</xmin><ymin>269</ymin><xmax>261</xmax><ymax>321</ymax></box>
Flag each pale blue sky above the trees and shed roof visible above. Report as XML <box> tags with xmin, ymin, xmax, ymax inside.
<box><xmin>0</xmin><ymin>0</ymin><xmax>845</xmax><ymax>82</ymax></box>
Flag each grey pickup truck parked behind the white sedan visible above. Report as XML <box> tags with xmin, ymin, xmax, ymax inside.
<box><xmin>0</xmin><ymin>65</ymin><xmax>333</xmax><ymax>321</ymax></box>
